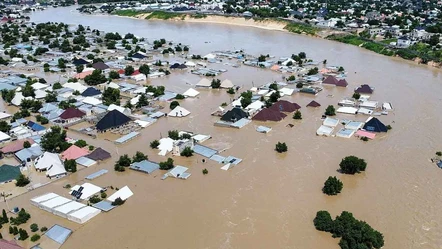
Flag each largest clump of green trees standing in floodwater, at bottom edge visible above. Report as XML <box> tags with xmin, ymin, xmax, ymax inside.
<box><xmin>313</xmin><ymin>211</ymin><xmax>384</xmax><ymax>249</ymax></box>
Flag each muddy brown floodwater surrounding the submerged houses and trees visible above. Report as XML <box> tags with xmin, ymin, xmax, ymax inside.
<box><xmin>0</xmin><ymin>7</ymin><xmax>442</xmax><ymax>249</ymax></box>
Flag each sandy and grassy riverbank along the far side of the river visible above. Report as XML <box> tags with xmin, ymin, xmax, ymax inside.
<box><xmin>114</xmin><ymin>10</ymin><xmax>442</xmax><ymax>68</ymax></box>
